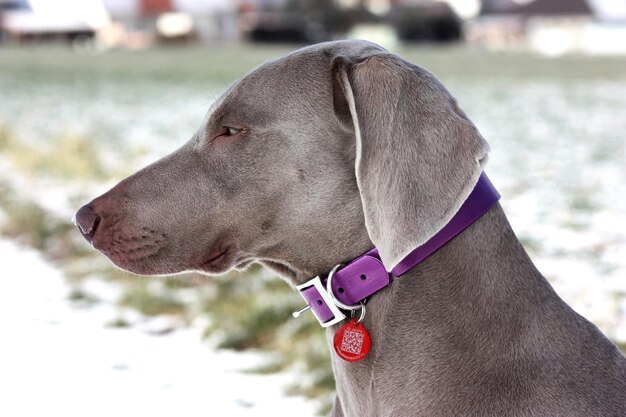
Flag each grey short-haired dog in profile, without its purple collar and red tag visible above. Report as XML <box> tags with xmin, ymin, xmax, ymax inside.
<box><xmin>76</xmin><ymin>41</ymin><xmax>626</xmax><ymax>417</ymax></box>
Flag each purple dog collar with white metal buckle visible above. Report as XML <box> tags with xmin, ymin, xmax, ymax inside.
<box><xmin>294</xmin><ymin>172</ymin><xmax>500</xmax><ymax>327</ymax></box>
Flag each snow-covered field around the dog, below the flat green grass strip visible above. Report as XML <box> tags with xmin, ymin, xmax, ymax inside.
<box><xmin>0</xmin><ymin>48</ymin><xmax>626</xmax><ymax>417</ymax></box>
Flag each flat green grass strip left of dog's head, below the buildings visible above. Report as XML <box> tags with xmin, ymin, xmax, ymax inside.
<box><xmin>0</xmin><ymin>45</ymin><xmax>291</xmax><ymax>86</ymax></box>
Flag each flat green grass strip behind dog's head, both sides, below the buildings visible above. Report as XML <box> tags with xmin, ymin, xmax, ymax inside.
<box><xmin>0</xmin><ymin>44</ymin><xmax>626</xmax><ymax>86</ymax></box>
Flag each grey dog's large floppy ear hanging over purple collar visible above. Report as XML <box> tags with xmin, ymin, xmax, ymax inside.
<box><xmin>332</xmin><ymin>52</ymin><xmax>489</xmax><ymax>271</ymax></box>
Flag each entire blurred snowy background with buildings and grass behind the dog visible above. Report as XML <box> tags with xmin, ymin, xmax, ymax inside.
<box><xmin>0</xmin><ymin>0</ymin><xmax>626</xmax><ymax>416</ymax></box>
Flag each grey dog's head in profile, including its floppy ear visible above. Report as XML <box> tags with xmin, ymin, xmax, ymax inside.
<box><xmin>76</xmin><ymin>41</ymin><xmax>488</xmax><ymax>282</ymax></box>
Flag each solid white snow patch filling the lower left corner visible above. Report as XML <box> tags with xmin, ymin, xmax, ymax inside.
<box><xmin>0</xmin><ymin>240</ymin><xmax>315</xmax><ymax>417</ymax></box>
